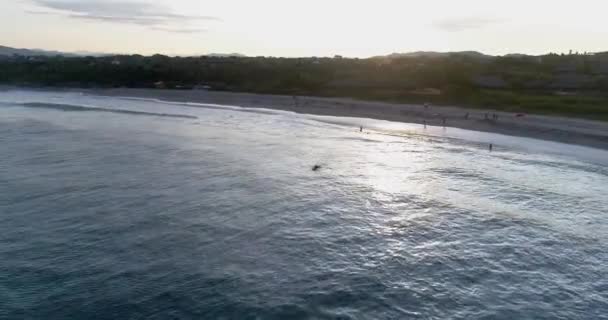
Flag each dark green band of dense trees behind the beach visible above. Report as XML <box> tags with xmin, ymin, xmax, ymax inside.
<box><xmin>0</xmin><ymin>52</ymin><xmax>608</xmax><ymax>119</ymax></box>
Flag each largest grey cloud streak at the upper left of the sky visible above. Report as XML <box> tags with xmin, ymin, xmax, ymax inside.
<box><xmin>28</xmin><ymin>0</ymin><xmax>220</xmax><ymax>30</ymax></box>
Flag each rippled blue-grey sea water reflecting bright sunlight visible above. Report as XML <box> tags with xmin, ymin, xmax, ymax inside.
<box><xmin>0</xmin><ymin>91</ymin><xmax>608</xmax><ymax>319</ymax></box>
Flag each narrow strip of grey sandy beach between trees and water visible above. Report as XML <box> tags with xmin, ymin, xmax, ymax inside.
<box><xmin>0</xmin><ymin>87</ymin><xmax>608</xmax><ymax>150</ymax></box>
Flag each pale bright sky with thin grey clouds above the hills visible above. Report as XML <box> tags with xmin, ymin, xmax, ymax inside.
<box><xmin>0</xmin><ymin>0</ymin><xmax>608</xmax><ymax>57</ymax></box>
